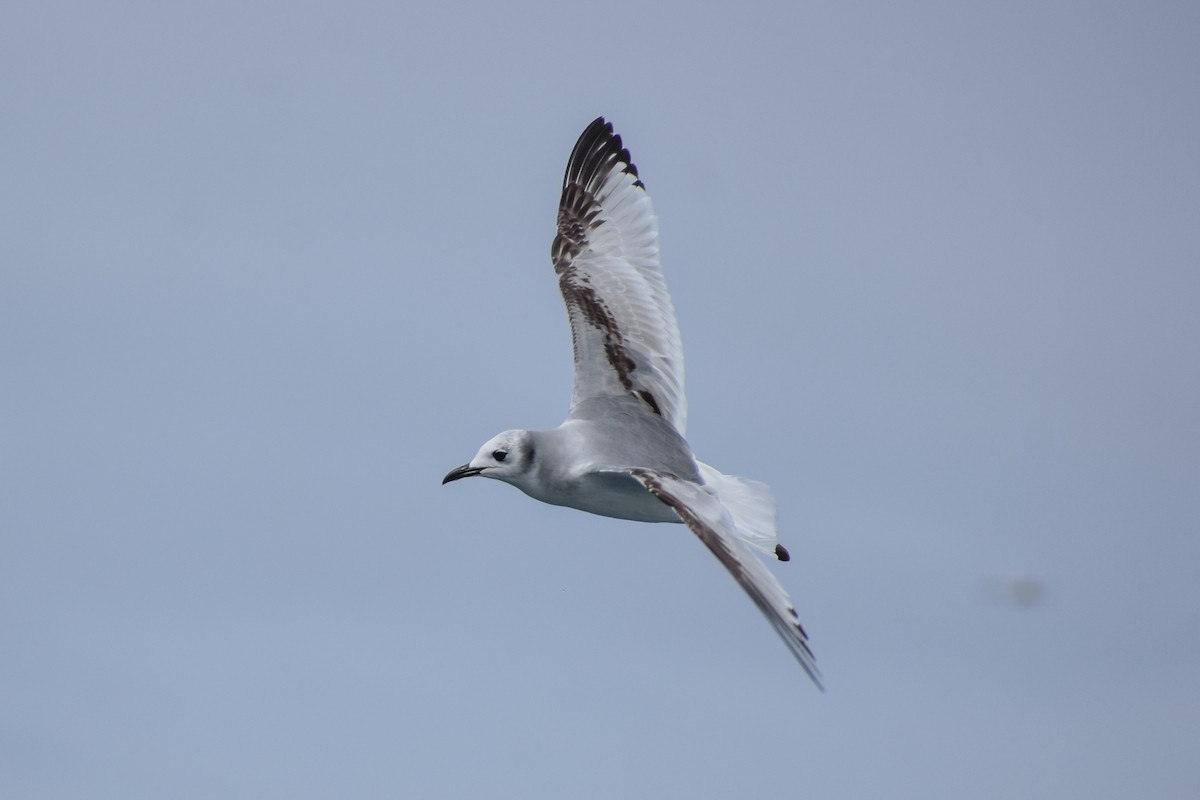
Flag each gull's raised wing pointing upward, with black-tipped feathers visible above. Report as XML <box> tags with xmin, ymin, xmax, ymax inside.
<box><xmin>550</xmin><ymin>118</ymin><xmax>688</xmax><ymax>435</ymax></box>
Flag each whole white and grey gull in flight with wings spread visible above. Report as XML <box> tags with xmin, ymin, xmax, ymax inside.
<box><xmin>442</xmin><ymin>118</ymin><xmax>821</xmax><ymax>687</ymax></box>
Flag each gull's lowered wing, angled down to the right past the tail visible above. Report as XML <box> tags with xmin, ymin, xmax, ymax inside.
<box><xmin>630</xmin><ymin>469</ymin><xmax>824</xmax><ymax>691</ymax></box>
